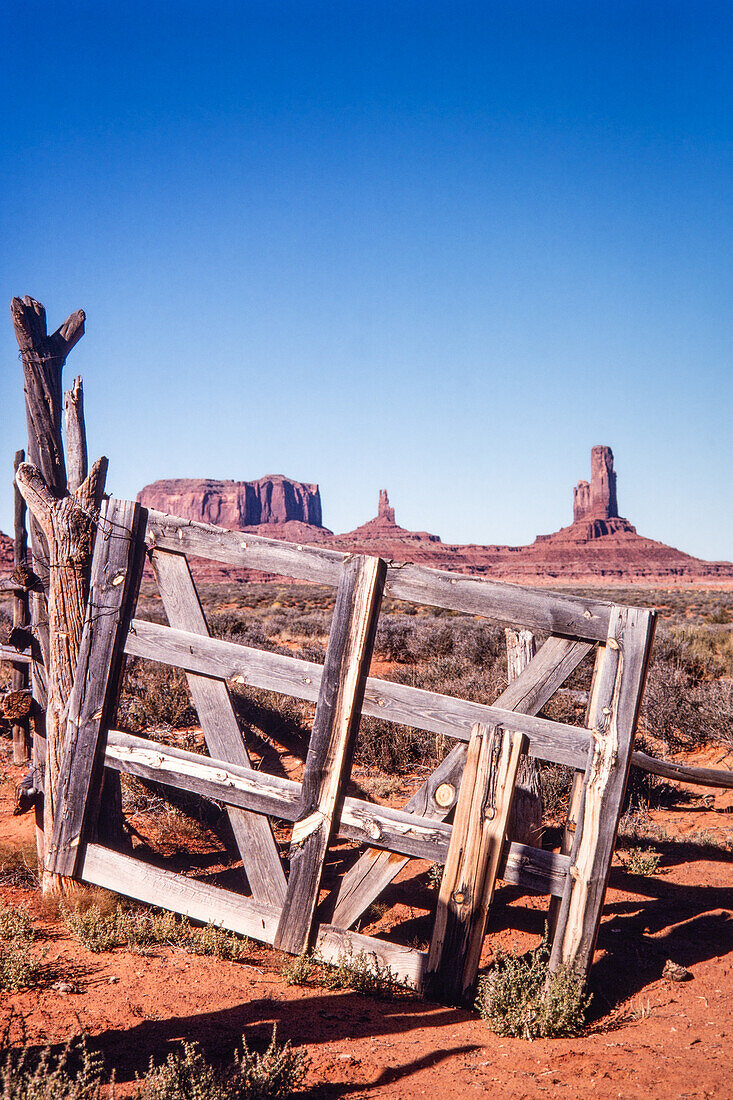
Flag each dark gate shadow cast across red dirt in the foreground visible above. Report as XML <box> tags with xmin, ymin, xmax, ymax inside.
<box><xmin>92</xmin><ymin>991</ymin><xmax>480</xmax><ymax>1100</ymax></box>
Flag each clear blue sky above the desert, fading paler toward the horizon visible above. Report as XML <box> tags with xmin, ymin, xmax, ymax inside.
<box><xmin>0</xmin><ymin>0</ymin><xmax>733</xmax><ymax>559</ymax></box>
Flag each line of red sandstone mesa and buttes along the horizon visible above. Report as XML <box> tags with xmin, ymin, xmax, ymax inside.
<box><xmin>122</xmin><ymin>447</ymin><xmax>733</xmax><ymax>584</ymax></box>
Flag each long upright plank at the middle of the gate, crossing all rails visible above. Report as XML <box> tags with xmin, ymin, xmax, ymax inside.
<box><xmin>275</xmin><ymin>557</ymin><xmax>386</xmax><ymax>954</ymax></box>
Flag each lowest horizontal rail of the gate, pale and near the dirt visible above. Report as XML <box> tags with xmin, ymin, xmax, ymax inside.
<box><xmin>80</xmin><ymin>844</ymin><xmax>426</xmax><ymax>989</ymax></box>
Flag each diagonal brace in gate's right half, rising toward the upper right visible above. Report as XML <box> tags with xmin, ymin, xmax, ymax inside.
<box><xmin>333</xmin><ymin>638</ymin><xmax>592</xmax><ymax>928</ymax></box>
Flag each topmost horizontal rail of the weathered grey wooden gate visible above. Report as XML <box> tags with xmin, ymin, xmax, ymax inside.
<box><xmin>145</xmin><ymin>510</ymin><xmax>612</xmax><ymax>641</ymax></box>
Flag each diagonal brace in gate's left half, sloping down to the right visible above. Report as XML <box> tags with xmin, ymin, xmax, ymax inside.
<box><xmin>150</xmin><ymin>550</ymin><xmax>286</xmax><ymax>905</ymax></box>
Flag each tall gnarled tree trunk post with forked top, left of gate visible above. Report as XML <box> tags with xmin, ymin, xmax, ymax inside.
<box><xmin>10</xmin><ymin>297</ymin><xmax>107</xmax><ymax>892</ymax></box>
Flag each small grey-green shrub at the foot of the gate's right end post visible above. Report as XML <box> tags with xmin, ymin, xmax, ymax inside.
<box><xmin>475</xmin><ymin>943</ymin><xmax>591</xmax><ymax>1040</ymax></box>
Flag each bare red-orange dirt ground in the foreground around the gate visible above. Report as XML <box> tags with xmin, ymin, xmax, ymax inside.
<box><xmin>0</xmin><ymin>752</ymin><xmax>733</xmax><ymax>1100</ymax></box>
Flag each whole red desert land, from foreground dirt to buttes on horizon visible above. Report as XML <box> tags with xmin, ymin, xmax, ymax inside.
<box><xmin>0</xmin><ymin>447</ymin><xmax>733</xmax><ymax>1100</ymax></box>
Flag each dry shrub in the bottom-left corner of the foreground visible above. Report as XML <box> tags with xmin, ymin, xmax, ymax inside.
<box><xmin>0</xmin><ymin>1019</ymin><xmax>102</xmax><ymax>1100</ymax></box>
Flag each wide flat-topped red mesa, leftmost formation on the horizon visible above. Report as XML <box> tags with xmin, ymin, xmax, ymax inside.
<box><xmin>138</xmin><ymin>474</ymin><xmax>326</xmax><ymax>531</ymax></box>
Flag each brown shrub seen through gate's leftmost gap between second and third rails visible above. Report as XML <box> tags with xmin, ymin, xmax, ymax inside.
<box><xmin>118</xmin><ymin>657</ymin><xmax>197</xmax><ymax>732</ymax></box>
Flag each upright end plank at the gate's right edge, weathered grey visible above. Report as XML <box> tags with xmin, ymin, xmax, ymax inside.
<box><xmin>550</xmin><ymin>607</ymin><xmax>656</xmax><ymax>978</ymax></box>
